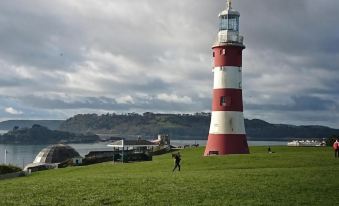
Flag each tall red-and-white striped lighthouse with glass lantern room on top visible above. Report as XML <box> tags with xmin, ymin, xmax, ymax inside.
<box><xmin>204</xmin><ymin>0</ymin><xmax>249</xmax><ymax>156</ymax></box>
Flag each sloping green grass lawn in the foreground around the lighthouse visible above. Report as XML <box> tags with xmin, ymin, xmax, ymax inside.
<box><xmin>0</xmin><ymin>147</ymin><xmax>339</xmax><ymax>206</ymax></box>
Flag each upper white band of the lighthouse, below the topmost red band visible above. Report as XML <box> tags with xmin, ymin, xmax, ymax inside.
<box><xmin>213</xmin><ymin>66</ymin><xmax>242</xmax><ymax>89</ymax></box>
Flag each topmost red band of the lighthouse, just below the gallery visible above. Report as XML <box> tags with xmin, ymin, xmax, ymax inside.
<box><xmin>213</xmin><ymin>46</ymin><xmax>243</xmax><ymax>67</ymax></box>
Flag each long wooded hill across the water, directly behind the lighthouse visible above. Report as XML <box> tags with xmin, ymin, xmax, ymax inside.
<box><xmin>60</xmin><ymin>112</ymin><xmax>339</xmax><ymax>140</ymax></box>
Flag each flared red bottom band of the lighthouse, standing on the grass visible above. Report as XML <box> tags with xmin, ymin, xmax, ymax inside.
<box><xmin>204</xmin><ymin>134</ymin><xmax>249</xmax><ymax>156</ymax></box>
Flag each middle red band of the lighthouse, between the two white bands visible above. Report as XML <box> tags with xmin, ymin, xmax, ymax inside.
<box><xmin>212</xmin><ymin>89</ymin><xmax>243</xmax><ymax>112</ymax></box>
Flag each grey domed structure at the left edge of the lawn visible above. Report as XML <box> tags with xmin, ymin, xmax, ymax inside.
<box><xmin>33</xmin><ymin>144</ymin><xmax>80</xmax><ymax>163</ymax></box>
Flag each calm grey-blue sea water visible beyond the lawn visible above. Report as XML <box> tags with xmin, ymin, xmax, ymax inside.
<box><xmin>0</xmin><ymin>140</ymin><xmax>287</xmax><ymax>168</ymax></box>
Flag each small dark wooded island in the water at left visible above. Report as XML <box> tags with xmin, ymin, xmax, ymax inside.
<box><xmin>0</xmin><ymin>124</ymin><xmax>99</xmax><ymax>144</ymax></box>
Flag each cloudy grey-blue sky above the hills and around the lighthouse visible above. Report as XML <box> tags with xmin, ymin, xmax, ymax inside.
<box><xmin>0</xmin><ymin>0</ymin><xmax>339</xmax><ymax>128</ymax></box>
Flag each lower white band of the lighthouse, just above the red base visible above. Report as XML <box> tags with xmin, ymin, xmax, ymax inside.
<box><xmin>209</xmin><ymin>111</ymin><xmax>246</xmax><ymax>134</ymax></box>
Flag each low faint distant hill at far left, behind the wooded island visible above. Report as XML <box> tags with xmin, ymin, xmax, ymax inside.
<box><xmin>0</xmin><ymin>120</ymin><xmax>64</xmax><ymax>130</ymax></box>
